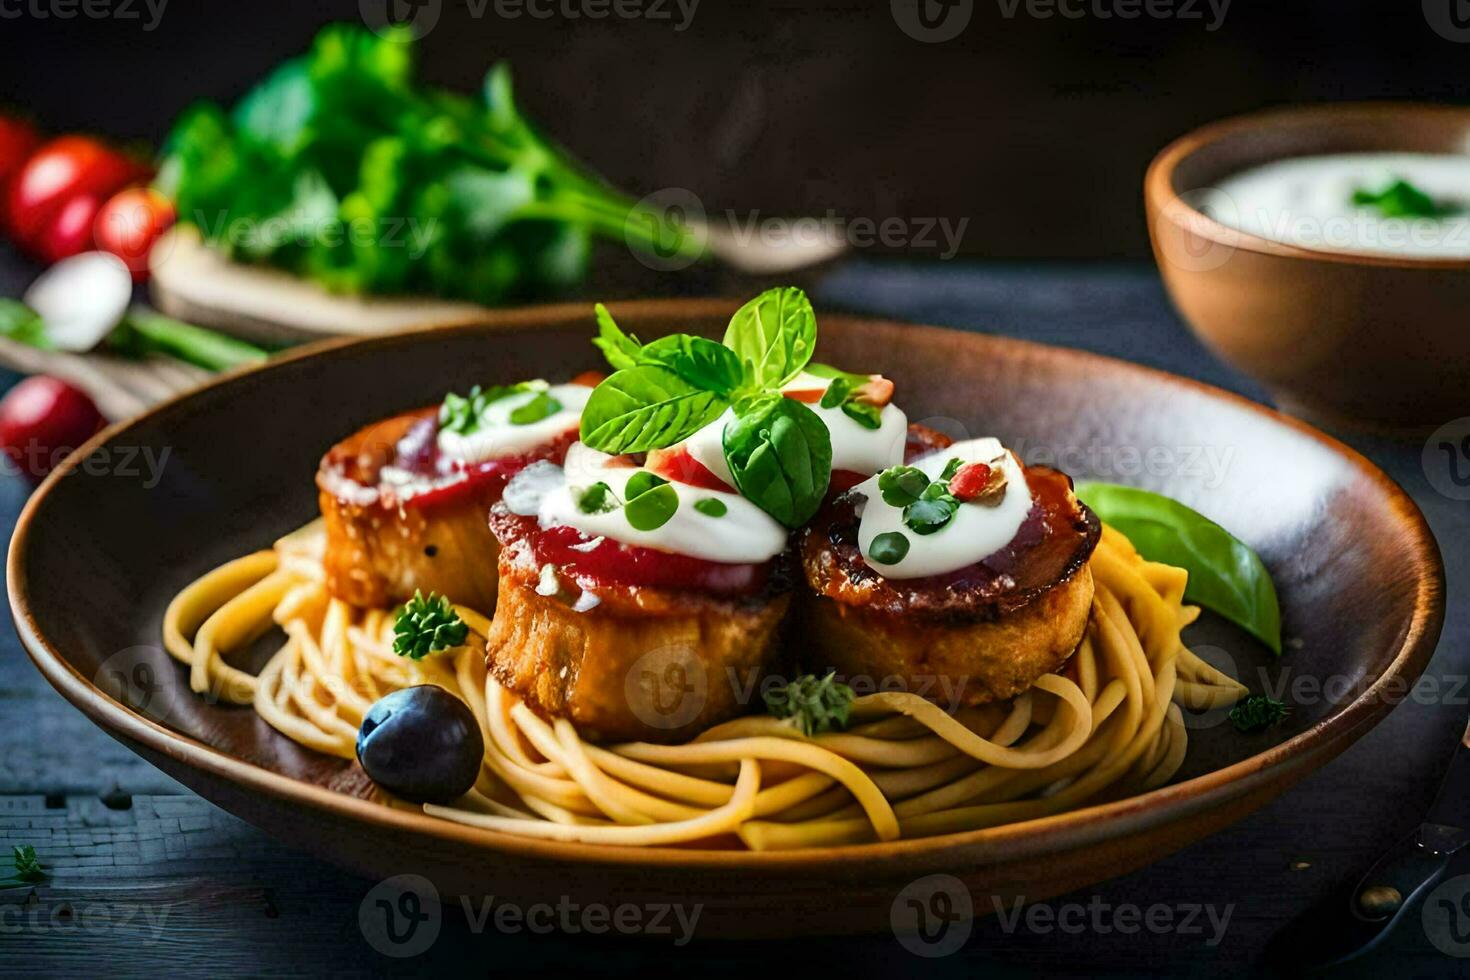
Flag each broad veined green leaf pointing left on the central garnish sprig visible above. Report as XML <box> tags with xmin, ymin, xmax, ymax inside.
<box><xmin>581</xmin><ymin>364</ymin><xmax>729</xmax><ymax>454</ymax></box>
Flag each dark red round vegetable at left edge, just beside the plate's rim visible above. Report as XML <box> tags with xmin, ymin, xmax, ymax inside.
<box><xmin>0</xmin><ymin>375</ymin><xmax>107</xmax><ymax>480</ymax></box>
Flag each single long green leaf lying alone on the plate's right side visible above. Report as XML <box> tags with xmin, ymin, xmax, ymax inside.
<box><xmin>1076</xmin><ymin>483</ymin><xmax>1282</xmax><ymax>655</ymax></box>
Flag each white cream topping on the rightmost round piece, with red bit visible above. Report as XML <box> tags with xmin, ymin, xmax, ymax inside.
<box><xmin>853</xmin><ymin>438</ymin><xmax>1032</xmax><ymax>579</ymax></box>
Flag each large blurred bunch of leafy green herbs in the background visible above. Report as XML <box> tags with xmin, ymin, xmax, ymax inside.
<box><xmin>159</xmin><ymin>24</ymin><xmax>703</xmax><ymax>303</ymax></box>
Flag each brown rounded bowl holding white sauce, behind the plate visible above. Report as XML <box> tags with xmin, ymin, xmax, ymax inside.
<box><xmin>1144</xmin><ymin>103</ymin><xmax>1470</xmax><ymax>430</ymax></box>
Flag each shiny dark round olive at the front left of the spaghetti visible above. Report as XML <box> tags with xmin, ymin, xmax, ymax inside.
<box><xmin>357</xmin><ymin>685</ymin><xmax>485</xmax><ymax>804</ymax></box>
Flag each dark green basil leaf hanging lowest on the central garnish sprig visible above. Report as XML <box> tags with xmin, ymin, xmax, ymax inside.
<box><xmin>725</xmin><ymin>392</ymin><xmax>832</xmax><ymax>527</ymax></box>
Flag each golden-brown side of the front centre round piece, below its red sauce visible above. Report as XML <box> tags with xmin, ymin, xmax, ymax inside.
<box><xmin>485</xmin><ymin>555</ymin><xmax>791</xmax><ymax>743</ymax></box>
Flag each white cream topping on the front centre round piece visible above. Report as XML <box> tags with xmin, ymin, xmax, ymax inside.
<box><xmin>529</xmin><ymin>442</ymin><xmax>786</xmax><ymax>564</ymax></box>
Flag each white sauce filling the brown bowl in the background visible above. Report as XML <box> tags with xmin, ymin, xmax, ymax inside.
<box><xmin>1194</xmin><ymin>153</ymin><xmax>1470</xmax><ymax>259</ymax></box>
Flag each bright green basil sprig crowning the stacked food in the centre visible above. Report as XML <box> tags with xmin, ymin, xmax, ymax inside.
<box><xmin>581</xmin><ymin>287</ymin><xmax>832</xmax><ymax>527</ymax></box>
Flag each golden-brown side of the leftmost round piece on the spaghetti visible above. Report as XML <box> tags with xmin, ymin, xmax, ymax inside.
<box><xmin>316</xmin><ymin>408</ymin><xmax>500</xmax><ymax>614</ymax></box>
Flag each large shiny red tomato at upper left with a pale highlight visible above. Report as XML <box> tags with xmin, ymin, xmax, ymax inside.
<box><xmin>9</xmin><ymin>137</ymin><xmax>148</xmax><ymax>254</ymax></box>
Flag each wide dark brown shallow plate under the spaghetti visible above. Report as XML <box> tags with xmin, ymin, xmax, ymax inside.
<box><xmin>9</xmin><ymin>301</ymin><xmax>1444</xmax><ymax>934</ymax></box>
